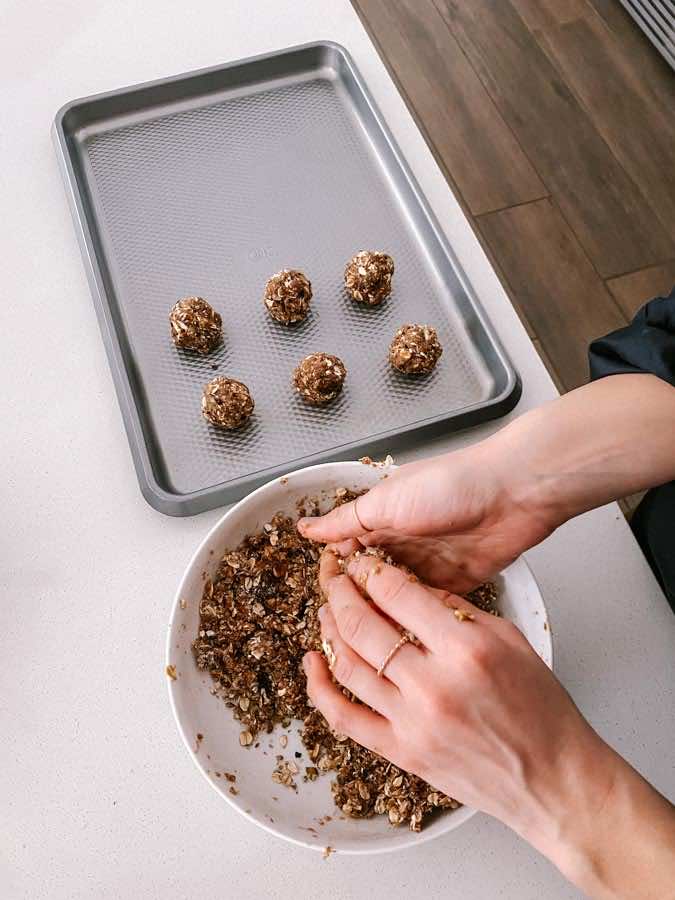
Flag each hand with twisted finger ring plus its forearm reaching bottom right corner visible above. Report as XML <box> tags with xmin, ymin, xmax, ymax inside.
<box><xmin>305</xmin><ymin>550</ymin><xmax>675</xmax><ymax>900</ymax></box>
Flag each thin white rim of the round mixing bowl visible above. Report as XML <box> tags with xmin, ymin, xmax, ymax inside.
<box><xmin>165</xmin><ymin>460</ymin><xmax>553</xmax><ymax>856</ymax></box>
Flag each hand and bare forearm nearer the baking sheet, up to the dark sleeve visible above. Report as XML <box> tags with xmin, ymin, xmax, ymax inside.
<box><xmin>298</xmin><ymin>375</ymin><xmax>675</xmax><ymax>592</ymax></box>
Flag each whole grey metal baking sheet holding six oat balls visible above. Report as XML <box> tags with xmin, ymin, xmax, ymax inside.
<box><xmin>54</xmin><ymin>42</ymin><xmax>520</xmax><ymax>515</ymax></box>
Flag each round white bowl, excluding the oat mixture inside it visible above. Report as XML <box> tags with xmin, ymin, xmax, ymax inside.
<box><xmin>166</xmin><ymin>462</ymin><xmax>552</xmax><ymax>853</ymax></box>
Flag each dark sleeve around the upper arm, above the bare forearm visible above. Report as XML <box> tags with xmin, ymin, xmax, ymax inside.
<box><xmin>589</xmin><ymin>287</ymin><xmax>675</xmax><ymax>386</ymax></box>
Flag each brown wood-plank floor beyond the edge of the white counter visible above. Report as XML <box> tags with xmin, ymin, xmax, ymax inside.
<box><xmin>354</xmin><ymin>0</ymin><xmax>675</xmax><ymax>391</ymax></box>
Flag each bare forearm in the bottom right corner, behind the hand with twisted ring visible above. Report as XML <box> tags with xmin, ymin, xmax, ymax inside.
<box><xmin>523</xmin><ymin>742</ymin><xmax>675</xmax><ymax>900</ymax></box>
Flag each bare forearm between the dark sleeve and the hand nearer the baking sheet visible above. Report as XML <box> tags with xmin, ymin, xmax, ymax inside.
<box><xmin>485</xmin><ymin>375</ymin><xmax>675</xmax><ymax>527</ymax></box>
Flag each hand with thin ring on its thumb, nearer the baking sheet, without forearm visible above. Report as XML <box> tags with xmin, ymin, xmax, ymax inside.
<box><xmin>298</xmin><ymin>438</ymin><xmax>559</xmax><ymax>592</ymax></box>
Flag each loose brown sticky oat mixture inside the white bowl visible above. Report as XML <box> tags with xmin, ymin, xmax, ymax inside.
<box><xmin>193</xmin><ymin>489</ymin><xmax>496</xmax><ymax>831</ymax></box>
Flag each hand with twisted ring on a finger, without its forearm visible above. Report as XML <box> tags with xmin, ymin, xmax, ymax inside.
<box><xmin>306</xmin><ymin>550</ymin><xmax>606</xmax><ymax>830</ymax></box>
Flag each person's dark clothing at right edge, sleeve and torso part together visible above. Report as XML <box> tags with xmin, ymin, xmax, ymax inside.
<box><xmin>589</xmin><ymin>287</ymin><xmax>675</xmax><ymax>611</ymax></box>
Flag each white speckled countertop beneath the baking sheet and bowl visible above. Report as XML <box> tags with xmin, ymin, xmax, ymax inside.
<box><xmin>0</xmin><ymin>0</ymin><xmax>675</xmax><ymax>900</ymax></box>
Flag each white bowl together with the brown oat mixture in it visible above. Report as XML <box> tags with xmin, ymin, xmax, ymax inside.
<box><xmin>166</xmin><ymin>462</ymin><xmax>551</xmax><ymax>853</ymax></box>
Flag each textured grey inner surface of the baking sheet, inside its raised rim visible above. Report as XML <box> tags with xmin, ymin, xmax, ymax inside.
<box><xmin>55</xmin><ymin>47</ymin><xmax>516</xmax><ymax>505</ymax></box>
